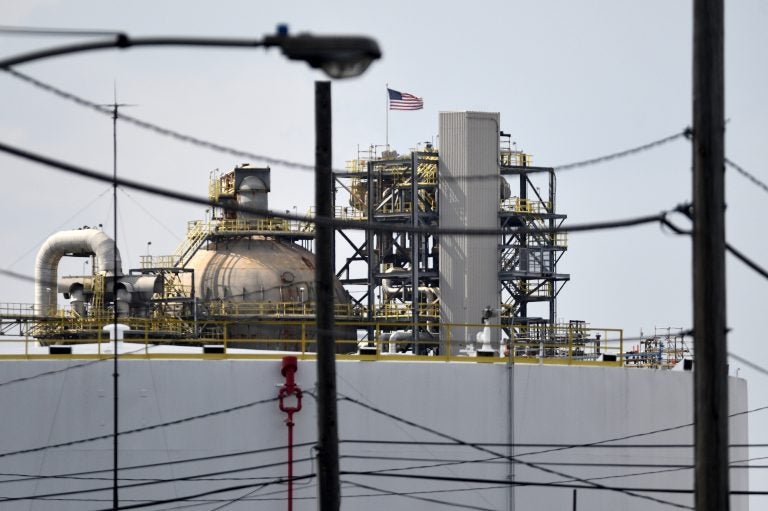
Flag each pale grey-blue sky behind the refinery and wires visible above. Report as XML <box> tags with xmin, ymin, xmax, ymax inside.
<box><xmin>0</xmin><ymin>0</ymin><xmax>768</xmax><ymax>502</ymax></box>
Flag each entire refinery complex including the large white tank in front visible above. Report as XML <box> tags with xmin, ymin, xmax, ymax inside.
<box><xmin>0</xmin><ymin>112</ymin><xmax>748</xmax><ymax>511</ymax></box>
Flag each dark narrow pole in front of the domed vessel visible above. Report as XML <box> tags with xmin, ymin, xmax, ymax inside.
<box><xmin>315</xmin><ymin>82</ymin><xmax>341</xmax><ymax>511</ymax></box>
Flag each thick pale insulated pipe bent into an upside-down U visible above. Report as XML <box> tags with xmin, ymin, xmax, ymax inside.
<box><xmin>35</xmin><ymin>229</ymin><xmax>123</xmax><ymax>315</ymax></box>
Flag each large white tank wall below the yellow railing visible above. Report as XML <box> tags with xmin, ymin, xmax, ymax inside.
<box><xmin>0</xmin><ymin>360</ymin><xmax>748</xmax><ymax>511</ymax></box>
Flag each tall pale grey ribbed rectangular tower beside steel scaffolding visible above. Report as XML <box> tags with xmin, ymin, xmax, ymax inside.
<box><xmin>438</xmin><ymin>112</ymin><xmax>500</xmax><ymax>349</ymax></box>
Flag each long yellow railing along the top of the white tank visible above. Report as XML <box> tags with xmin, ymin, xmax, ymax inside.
<box><xmin>0</xmin><ymin>318</ymin><xmax>629</xmax><ymax>366</ymax></box>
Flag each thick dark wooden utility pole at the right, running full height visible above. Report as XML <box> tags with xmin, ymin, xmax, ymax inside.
<box><xmin>693</xmin><ymin>0</ymin><xmax>729</xmax><ymax>511</ymax></box>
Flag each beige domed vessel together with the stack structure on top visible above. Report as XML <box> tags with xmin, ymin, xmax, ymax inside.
<box><xmin>176</xmin><ymin>165</ymin><xmax>356</xmax><ymax>352</ymax></box>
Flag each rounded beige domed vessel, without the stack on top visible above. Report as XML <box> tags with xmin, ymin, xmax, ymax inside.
<box><xmin>187</xmin><ymin>237</ymin><xmax>356</xmax><ymax>353</ymax></box>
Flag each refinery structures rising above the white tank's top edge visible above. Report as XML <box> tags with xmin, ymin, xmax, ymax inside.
<box><xmin>2</xmin><ymin>112</ymin><xmax>660</xmax><ymax>368</ymax></box>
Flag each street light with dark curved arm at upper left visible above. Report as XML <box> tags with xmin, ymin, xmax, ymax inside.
<box><xmin>0</xmin><ymin>25</ymin><xmax>381</xmax><ymax>78</ymax></box>
